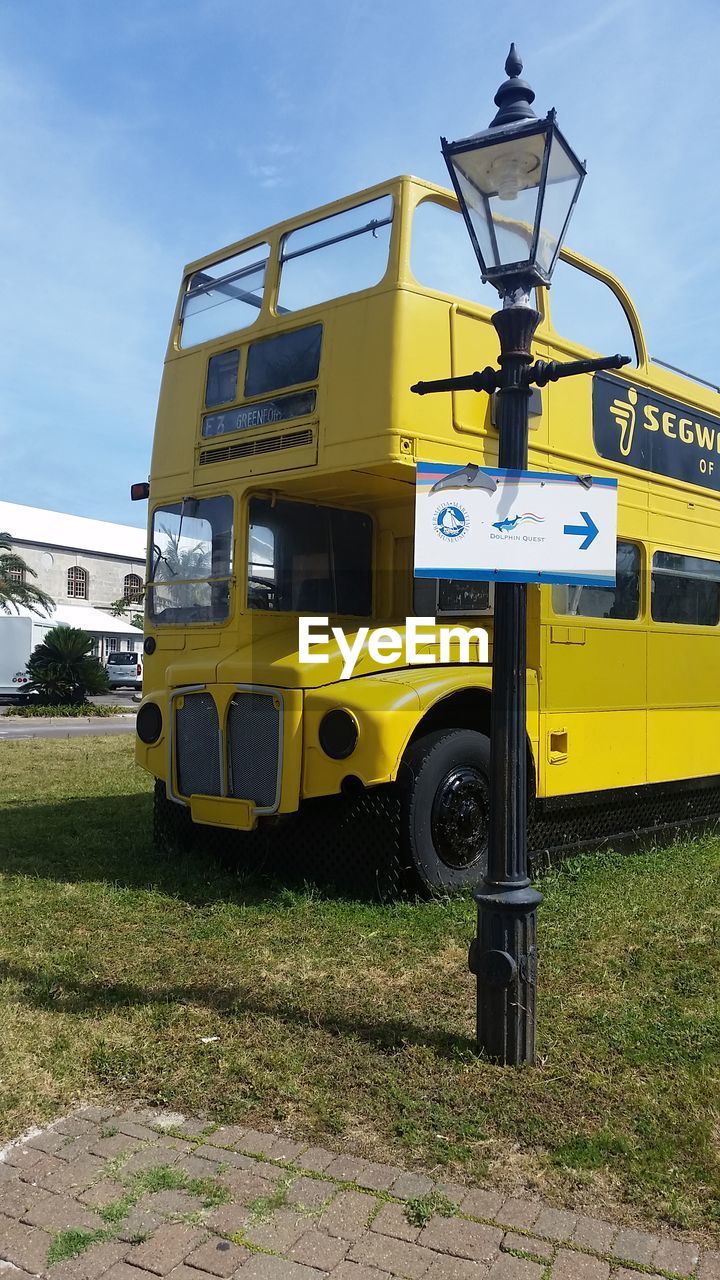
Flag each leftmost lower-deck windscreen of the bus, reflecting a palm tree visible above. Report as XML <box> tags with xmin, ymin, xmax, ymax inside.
<box><xmin>147</xmin><ymin>497</ymin><xmax>232</xmax><ymax>623</ymax></box>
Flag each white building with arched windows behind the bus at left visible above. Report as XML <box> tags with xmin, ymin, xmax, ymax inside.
<box><xmin>0</xmin><ymin>502</ymin><xmax>147</xmax><ymax>662</ymax></box>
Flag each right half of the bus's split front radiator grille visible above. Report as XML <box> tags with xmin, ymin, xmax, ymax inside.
<box><xmin>227</xmin><ymin>691</ymin><xmax>282</xmax><ymax>812</ymax></box>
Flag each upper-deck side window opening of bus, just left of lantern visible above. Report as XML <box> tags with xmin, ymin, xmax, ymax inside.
<box><xmin>410</xmin><ymin>200</ymin><xmax>501</xmax><ymax>311</ymax></box>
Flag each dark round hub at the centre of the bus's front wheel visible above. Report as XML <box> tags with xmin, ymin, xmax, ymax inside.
<box><xmin>432</xmin><ymin>765</ymin><xmax>488</xmax><ymax>870</ymax></box>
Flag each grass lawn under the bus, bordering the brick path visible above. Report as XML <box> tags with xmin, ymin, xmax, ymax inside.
<box><xmin>0</xmin><ymin>736</ymin><xmax>720</xmax><ymax>1230</ymax></box>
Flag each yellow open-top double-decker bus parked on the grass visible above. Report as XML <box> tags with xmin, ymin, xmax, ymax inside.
<box><xmin>137</xmin><ymin>177</ymin><xmax>720</xmax><ymax>890</ymax></box>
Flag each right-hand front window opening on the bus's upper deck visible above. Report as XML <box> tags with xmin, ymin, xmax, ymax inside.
<box><xmin>278</xmin><ymin>196</ymin><xmax>392</xmax><ymax>311</ymax></box>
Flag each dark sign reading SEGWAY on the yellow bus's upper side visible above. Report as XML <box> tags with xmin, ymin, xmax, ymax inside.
<box><xmin>592</xmin><ymin>374</ymin><xmax>720</xmax><ymax>489</ymax></box>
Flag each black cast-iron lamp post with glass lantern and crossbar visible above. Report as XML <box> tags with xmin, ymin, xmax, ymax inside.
<box><xmin>413</xmin><ymin>45</ymin><xmax>628</xmax><ymax>1066</ymax></box>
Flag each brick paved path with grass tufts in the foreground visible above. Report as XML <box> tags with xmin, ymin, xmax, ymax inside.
<box><xmin>0</xmin><ymin>1107</ymin><xmax>720</xmax><ymax>1280</ymax></box>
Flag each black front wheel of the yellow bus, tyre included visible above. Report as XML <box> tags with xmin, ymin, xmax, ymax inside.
<box><xmin>400</xmin><ymin>728</ymin><xmax>489</xmax><ymax>893</ymax></box>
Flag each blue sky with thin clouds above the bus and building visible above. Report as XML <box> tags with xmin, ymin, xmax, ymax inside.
<box><xmin>0</xmin><ymin>0</ymin><xmax>720</xmax><ymax>532</ymax></box>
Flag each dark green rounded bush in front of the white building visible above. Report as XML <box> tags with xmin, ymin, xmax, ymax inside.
<box><xmin>23</xmin><ymin>626</ymin><xmax>110</xmax><ymax>707</ymax></box>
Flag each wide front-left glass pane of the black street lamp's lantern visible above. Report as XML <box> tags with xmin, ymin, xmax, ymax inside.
<box><xmin>452</xmin><ymin>132</ymin><xmax>544</xmax><ymax>269</ymax></box>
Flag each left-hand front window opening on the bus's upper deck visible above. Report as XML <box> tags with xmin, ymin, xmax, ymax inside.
<box><xmin>181</xmin><ymin>243</ymin><xmax>269</xmax><ymax>347</ymax></box>
